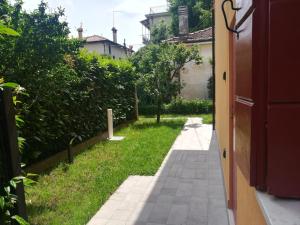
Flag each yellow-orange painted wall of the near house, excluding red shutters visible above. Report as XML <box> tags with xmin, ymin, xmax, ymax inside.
<box><xmin>215</xmin><ymin>0</ymin><xmax>266</xmax><ymax>225</ymax></box>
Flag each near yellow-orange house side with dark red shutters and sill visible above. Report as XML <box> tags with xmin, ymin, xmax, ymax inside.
<box><xmin>214</xmin><ymin>0</ymin><xmax>300</xmax><ymax>225</ymax></box>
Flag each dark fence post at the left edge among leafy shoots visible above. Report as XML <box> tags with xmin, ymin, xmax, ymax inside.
<box><xmin>0</xmin><ymin>89</ymin><xmax>27</xmax><ymax>219</ymax></box>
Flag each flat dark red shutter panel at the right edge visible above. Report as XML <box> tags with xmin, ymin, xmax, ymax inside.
<box><xmin>267</xmin><ymin>0</ymin><xmax>300</xmax><ymax>197</ymax></box>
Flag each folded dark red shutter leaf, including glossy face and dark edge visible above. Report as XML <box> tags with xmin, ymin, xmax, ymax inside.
<box><xmin>234</xmin><ymin>0</ymin><xmax>267</xmax><ymax>189</ymax></box>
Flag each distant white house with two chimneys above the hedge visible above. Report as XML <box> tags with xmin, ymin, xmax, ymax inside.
<box><xmin>77</xmin><ymin>27</ymin><xmax>133</xmax><ymax>59</ymax></box>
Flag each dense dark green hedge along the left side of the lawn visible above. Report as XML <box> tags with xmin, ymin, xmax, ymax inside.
<box><xmin>20</xmin><ymin>51</ymin><xmax>135</xmax><ymax>164</ymax></box>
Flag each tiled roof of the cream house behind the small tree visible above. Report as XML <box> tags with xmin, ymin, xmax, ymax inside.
<box><xmin>166</xmin><ymin>27</ymin><xmax>213</xmax><ymax>43</ymax></box>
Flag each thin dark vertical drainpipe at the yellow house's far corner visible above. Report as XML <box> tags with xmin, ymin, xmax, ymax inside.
<box><xmin>211</xmin><ymin>1</ymin><xmax>216</xmax><ymax>130</ymax></box>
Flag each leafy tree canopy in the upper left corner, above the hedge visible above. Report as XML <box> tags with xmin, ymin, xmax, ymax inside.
<box><xmin>0</xmin><ymin>0</ymin><xmax>80</xmax><ymax>85</ymax></box>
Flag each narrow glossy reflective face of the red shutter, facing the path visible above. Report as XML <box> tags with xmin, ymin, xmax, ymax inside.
<box><xmin>234</xmin><ymin>11</ymin><xmax>255</xmax><ymax>185</ymax></box>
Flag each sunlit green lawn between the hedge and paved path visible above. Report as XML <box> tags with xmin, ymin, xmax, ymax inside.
<box><xmin>26</xmin><ymin>117</ymin><xmax>186</xmax><ymax>225</ymax></box>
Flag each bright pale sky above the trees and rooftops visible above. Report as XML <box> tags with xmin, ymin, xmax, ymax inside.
<box><xmin>14</xmin><ymin>0</ymin><xmax>167</xmax><ymax>50</ymax></box>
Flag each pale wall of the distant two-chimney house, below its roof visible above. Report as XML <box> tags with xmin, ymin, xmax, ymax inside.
<box><xmin>84</xmin><ymin>42</ymin><xmax>128</xmax><ymax>59</ymax></box>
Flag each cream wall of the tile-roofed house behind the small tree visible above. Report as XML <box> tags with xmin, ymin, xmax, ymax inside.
<box><xmin>180</xmin><ymin>42</ymin><xmax>212</xmax><ymax>99</ymax></box>
